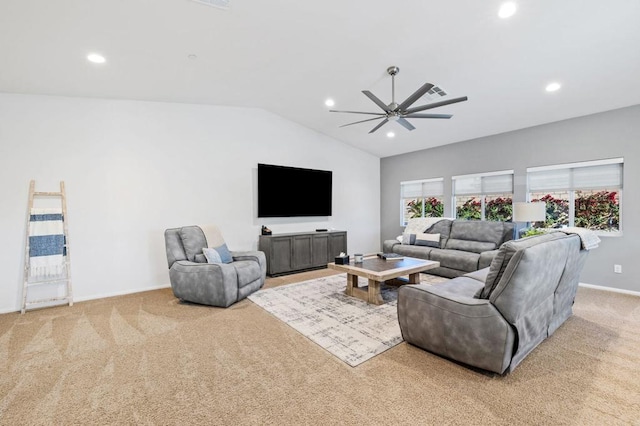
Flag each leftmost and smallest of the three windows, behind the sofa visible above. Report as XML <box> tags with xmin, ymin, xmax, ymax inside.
<box><xmin>400</xmin><ymin>178</ymin><xmax>444</xmax><ymax>226</ymax></box>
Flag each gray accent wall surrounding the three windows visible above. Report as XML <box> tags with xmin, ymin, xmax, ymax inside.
<box><xmin>380</xmin><ymin>105</ymin><xmax>640</xmax><ymax>292</ymax></box>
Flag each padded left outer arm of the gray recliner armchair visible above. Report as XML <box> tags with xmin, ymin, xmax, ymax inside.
<box><xmin>169</xmin><ymin>260</ymin><xmax>238</xmax><ymax>308</ymax></box>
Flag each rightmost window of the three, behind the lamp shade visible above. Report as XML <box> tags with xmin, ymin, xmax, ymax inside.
<box><xmin>527</xmin><ymin>158</ymin><xmax>624</xmax><ymax>233</ymax></box>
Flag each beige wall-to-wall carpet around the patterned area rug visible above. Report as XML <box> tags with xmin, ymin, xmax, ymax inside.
<box><xmin>0</xmin><ymin>270</ymin><xmax>640</xmax><ymax>425</ymax></box>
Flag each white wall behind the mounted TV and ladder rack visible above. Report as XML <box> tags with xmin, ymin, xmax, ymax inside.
<box><xmin>0</xmin><ymin>94</ymin><xmax>380</xmax><ymax>312</ymax></box>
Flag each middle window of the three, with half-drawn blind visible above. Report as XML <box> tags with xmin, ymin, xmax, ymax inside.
<box><xmin>452</xmin><ymin>170</ymin><xmax>513</xmax><ymax>222</ymax></box>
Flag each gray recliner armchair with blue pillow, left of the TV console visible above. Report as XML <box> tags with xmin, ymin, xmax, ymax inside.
<box><xmin>164</xmin><ymin>226</ymin><xmax>267</xmax><ymax>308</ymax></box>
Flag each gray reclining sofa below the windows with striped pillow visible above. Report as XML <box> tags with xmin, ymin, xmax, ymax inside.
<box><xmin>383</xmin><ymin>219</ymin><xmax>514</xmax><ymax>278</ymax></box>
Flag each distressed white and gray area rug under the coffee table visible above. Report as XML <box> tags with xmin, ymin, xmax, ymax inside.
<box><xmin>249</xmin><ymin>274</ymin><xmax>447</xmax><ymax>367</ymax></box>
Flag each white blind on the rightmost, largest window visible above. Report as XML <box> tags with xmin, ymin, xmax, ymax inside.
<box><xmin>527</xmin><ymin>158</ymin><xmax>622</xmax><ymax>192</ymax></box>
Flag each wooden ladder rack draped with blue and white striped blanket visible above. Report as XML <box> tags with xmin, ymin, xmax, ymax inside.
<box><xmin>21</xmin><ymin>180</ymin><xmax>73</xmax><ymax>314</ymax></box>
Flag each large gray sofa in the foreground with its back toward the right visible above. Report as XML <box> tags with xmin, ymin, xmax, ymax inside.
<box><xmin>398</xmin><ymin>232</ymin><xmax>587</xmax><ymax>374</ymax></box>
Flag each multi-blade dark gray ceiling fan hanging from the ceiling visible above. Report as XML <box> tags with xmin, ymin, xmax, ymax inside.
<box><xmin>329</xmin><ymin>66</ymin><xmax>467</xmax><ymax>133</ymax></box>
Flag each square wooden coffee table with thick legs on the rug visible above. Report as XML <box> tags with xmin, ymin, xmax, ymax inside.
<box><xmin>327</xmin><ymin>255</ymin><xmax>440</xmax><ymax>305</ymax></box>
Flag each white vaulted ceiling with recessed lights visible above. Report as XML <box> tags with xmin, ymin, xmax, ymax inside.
<box><xmin>0</xmin><ymin>0</ymin><xmax>640</xmax><ymax>157</ymax></box>
